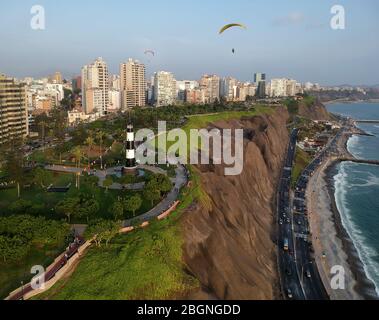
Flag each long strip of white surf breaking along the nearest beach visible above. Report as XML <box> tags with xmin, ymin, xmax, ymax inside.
<box><xmin>334</xmin><ymin>163</ymin><xmax>379</xmax><ymax>296</ymax></box>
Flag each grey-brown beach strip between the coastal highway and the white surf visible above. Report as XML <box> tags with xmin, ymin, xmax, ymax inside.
<box><xmin>307</xmin><ymin>129</ymin><xmax>377</xmax><ymax>300</ymax></box>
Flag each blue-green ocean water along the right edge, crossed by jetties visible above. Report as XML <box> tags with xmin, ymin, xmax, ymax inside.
<box><xmin>327</xmin><ymin>103</ymin><xmax>379</xmax><ymax>296</ymax></box>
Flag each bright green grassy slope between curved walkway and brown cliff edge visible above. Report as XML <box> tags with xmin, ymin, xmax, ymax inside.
<box><xmin>36</xmin><ymin>166</ymin><xmax>205</xmax><ymax>300</ymax></box>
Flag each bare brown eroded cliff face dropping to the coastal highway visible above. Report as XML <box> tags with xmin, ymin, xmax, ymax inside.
<box><xmin>182</xmin><ymin>108</ymin><xmax>289</xmax><ymax>300</ymax></box>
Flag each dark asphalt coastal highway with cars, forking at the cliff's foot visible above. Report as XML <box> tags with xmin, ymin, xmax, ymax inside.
<box><xmin>277</xmin><ymin>129</ymin><xmax>337</xmax><ymax>300</ymax></box>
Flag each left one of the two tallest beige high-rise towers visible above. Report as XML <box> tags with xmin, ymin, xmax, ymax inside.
<box><xmin>82</xmin><ymin>58</ymin><xmax>109</xmax><ymax>116</ymax></box>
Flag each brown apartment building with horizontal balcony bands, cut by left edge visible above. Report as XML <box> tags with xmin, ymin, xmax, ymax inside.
<box><xmin>0</xmin><ymin>74</ymin><xmax>28</xmax><ymax>144</ymax></box>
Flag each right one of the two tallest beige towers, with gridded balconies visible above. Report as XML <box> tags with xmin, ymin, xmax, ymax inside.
<box><xmin>120</xmin><ymin>59</ymin><xmax>146</xmax><ymax>110</ymax></box>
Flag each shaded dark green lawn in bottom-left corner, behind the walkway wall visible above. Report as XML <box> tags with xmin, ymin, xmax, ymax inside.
<box><xmin>0</xmin><ymin>243</ymin><xmax>65</xmax><ymax>299</ymax></box>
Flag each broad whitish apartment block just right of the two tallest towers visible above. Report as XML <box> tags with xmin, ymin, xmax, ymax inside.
<box><xmin>154</xmin><ymin>71</ymin><xmax>177</xmax><ymax>107</ymax></box>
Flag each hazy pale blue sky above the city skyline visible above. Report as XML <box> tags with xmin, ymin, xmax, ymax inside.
<box><xmin>0</xmin><ymin>0</ymin><xmax>379</xmax><ymax>85</ymax></box>
